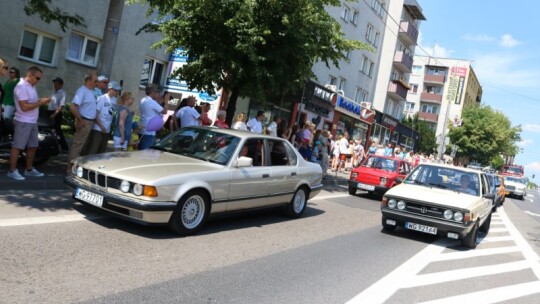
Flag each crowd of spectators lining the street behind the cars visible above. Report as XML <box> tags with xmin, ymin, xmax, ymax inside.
<box><xmin>0</xmin><ymin>58</ymin><xmax>442</xmax><ymax>180</ymax></box>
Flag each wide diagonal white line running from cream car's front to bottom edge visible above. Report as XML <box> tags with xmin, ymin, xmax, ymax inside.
<box><xmin>347</xmin><ymin>239</ymin><xmax>450</xmax><ymax>304</ymax></box>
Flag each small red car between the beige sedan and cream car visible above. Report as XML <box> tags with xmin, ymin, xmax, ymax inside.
<box><xmin>349</xmin><ymin>155</ymin><xmax>412</xmax><ymax>195</ymax></box>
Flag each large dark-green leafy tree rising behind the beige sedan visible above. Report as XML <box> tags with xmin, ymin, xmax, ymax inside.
<box><xmin>130</xmin><ymin>0</ymin><xmax>370</xmax><ymax>123</ymax></box>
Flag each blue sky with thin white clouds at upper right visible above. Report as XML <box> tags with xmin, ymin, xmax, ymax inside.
<box><xmin>416</xmin><ymin>0</ymin><xmax>540</xmax><ymax>184</ymax></box>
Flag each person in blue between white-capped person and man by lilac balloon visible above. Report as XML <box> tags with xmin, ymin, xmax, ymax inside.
<box><xmin>113</xmin><ymin>92</ymin><xmax>134</xmax><ymax>151</ymax></box>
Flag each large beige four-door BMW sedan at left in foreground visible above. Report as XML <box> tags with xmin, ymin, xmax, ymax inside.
<box><xmin>65</xmin><ymin>127</ymin><xmax>322</xmax><ymax>235</ymax></box>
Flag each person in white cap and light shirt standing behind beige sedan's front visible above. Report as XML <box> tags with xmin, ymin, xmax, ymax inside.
<box><xmin>82</xmin><ymin>81</ymin><xmax>122</xmax><ymax>155</ymax></box>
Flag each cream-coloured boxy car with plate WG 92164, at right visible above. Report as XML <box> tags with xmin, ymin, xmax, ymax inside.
<box><xmin>381</xmin><ymin>163</ymin><xmax>495</xmax><ymax>248</ymax></box>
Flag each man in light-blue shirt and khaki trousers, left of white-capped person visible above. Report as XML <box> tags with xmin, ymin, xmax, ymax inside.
<box><xmin>67</xmin><ymin>74</ymin><xmax>97</xmax><ymax>175</ymax></box>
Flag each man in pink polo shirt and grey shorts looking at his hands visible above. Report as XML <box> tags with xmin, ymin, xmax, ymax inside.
<box><xmin>7</xmin><ymin>66</ymin><xmax>51</xmax><ymax>180</ymax></box>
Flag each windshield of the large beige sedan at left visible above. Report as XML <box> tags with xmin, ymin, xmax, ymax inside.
<box><xmin>152</xmin><ymin>128</ymin><xmax>240</xmax><ymax>165</ymax></box>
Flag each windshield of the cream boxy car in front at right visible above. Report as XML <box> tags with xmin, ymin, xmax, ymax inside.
<box><xmin>403</xmin><ymin>164</ymin><xmax>480</xmax><ymax>196</ymax></box>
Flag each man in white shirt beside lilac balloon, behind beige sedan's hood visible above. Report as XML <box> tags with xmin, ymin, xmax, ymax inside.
<box><xmin>139</xmin><ymin>84</ymin><xmax>167</xmax><ymax>150</ymax></box>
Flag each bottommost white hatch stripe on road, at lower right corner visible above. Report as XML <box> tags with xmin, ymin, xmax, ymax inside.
<box><xmin>420</xmin><ymin>281</ymin><xmax>540</xmax><ymax>304</ymax></box>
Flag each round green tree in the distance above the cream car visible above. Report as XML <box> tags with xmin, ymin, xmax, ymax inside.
<box><xmin>448</xmin><ymin>105</ymin><xmax>521</xmax><ymax>165</ymax></box>
